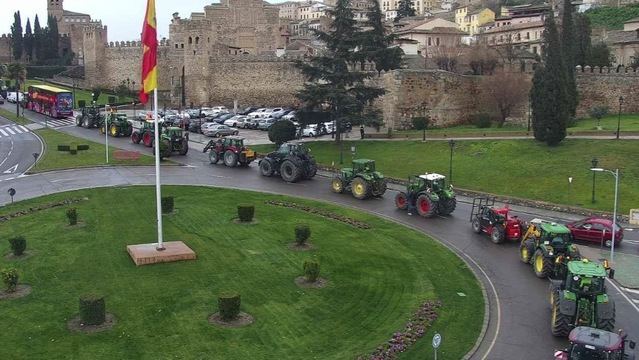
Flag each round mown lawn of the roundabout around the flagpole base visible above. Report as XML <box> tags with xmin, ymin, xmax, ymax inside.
<box><xmin>0</xmin><ymin>186</ymin><xmax>484</xmax><ymax>359</ymax></box>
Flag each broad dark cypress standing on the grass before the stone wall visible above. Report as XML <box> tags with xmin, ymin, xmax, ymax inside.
<box><xmin>530</xmin><ymin>16</ymin><xmax>570</xmax><ymax>146</ymax></box>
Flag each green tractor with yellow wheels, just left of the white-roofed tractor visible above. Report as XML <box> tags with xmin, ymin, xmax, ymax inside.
<box><xmin>331</xmin><ymin>159</ymin><xmax>386</xmax><ymax>200</ymax></box>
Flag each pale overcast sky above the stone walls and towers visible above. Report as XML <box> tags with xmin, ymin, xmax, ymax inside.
<box><xmin>0</xmin><ymin>0</ymin><xmax>292</xmax><ymax>41</ymax></box>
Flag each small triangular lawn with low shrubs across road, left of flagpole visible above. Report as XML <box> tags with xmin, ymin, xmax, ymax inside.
<box><xmin>31</xmin><ymin>129</ymin><xmax>155</xmax><ymax>172</ymax></box>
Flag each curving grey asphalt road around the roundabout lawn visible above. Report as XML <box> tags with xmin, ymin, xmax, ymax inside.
<box><xmin>0</xmin><ymin>107</ymin><xmax>639</xmax><ymax>360</ymax></box>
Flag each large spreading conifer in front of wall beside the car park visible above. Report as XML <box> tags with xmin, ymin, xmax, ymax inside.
<box><xmin>296</xmin><ymin>0</ymin><xmax>384</xmax><ymax>142</ymax></box>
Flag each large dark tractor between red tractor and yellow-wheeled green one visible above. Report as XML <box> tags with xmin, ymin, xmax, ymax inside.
<box><xmin>259</xmin><ymin>141</ymin><xmax>317</xmax><ymax>182</ymax></box>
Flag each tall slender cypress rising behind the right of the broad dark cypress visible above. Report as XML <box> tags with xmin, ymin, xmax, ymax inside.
<box><xmin>561</xmin><ymin>0</ymin><xmax>579</xmax><ymax>117</ymax></box>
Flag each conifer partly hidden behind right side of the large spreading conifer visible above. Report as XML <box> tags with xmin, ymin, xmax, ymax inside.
<box><xmin>357</xmin><ymin>1</ymin><xmax>404</xmax><ymax>75</ymax></box>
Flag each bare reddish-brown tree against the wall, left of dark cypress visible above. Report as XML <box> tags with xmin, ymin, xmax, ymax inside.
<box><xmin>482</xmin><ymin>71</ymin><xmax>529</xmax><ymax>127</ymax></box>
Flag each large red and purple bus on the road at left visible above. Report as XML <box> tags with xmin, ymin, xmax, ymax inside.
<box><xmin>26</xmin><ymin>85</ymin><xmax>73</xmax><ymax>119</ymax></box>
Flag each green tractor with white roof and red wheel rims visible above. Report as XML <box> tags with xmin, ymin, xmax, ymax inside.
<box><xmin>395</xmin><ymin>173</ymin><xmax>457</xmax><ymax>218</ymax></box>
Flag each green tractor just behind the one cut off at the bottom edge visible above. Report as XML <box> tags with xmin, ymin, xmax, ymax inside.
<box><xmin>550</xmin><ymin>259</ymin><xmax>615</xmax><ymax>336</ymax></box>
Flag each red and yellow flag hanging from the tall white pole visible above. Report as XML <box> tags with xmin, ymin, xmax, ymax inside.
<box><xmin>140</xmin><ymin>0</ymin><xmax>158</xmax><ymax>104</ymax></box>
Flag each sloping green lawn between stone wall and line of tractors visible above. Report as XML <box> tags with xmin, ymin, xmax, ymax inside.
<box><xmin>253</xmin><ymin>139</ymin><xmax>639</xmax><ymax>214</ymax></box>
